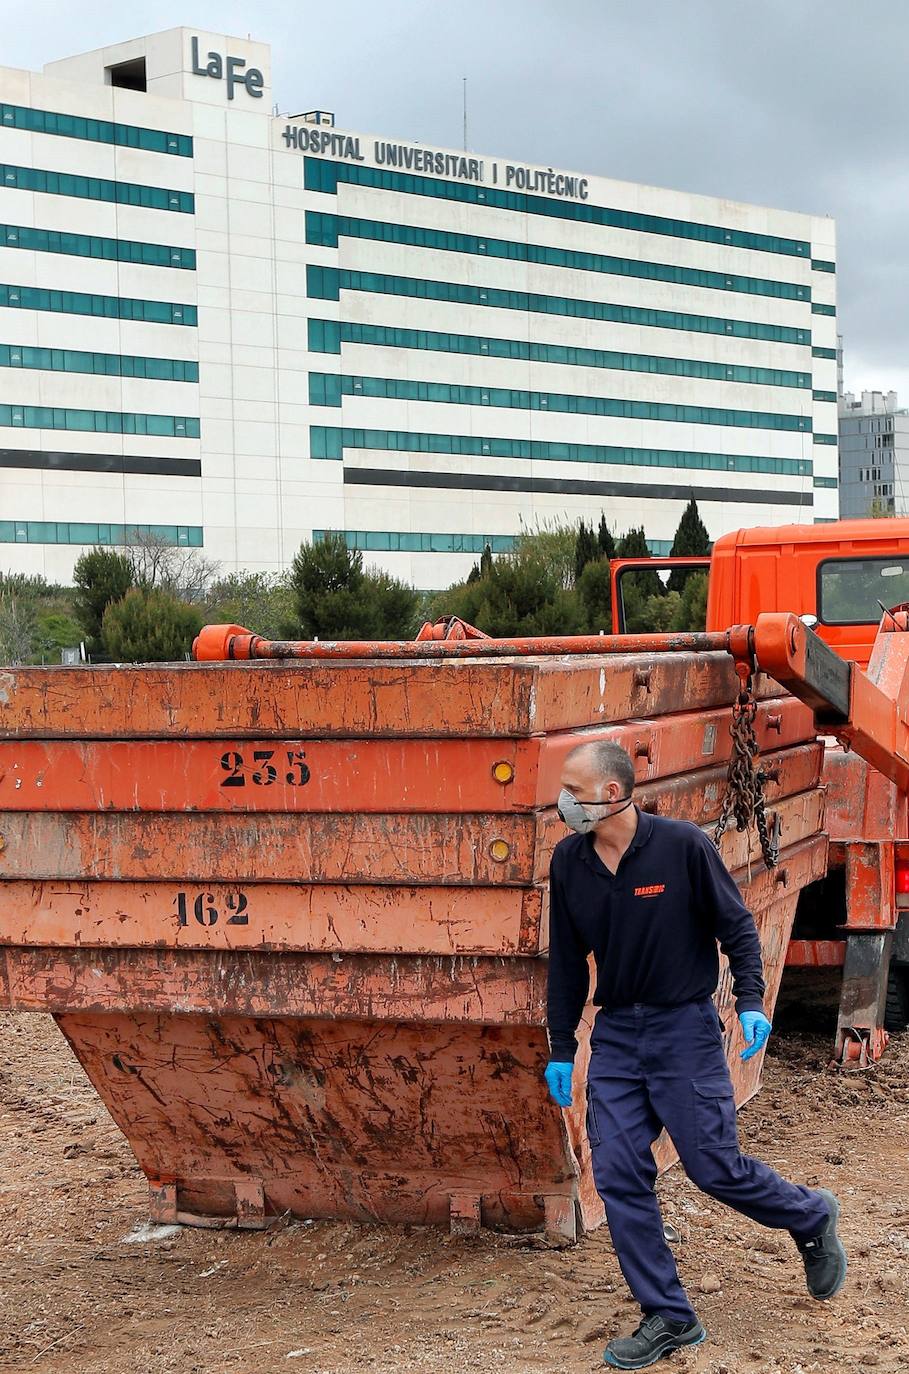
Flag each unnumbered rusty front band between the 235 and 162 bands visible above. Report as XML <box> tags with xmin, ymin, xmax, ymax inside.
<box><xmin>0</xmin><ymin>811</ymin><xmax>536</xmax><ymax>886</ymax></box>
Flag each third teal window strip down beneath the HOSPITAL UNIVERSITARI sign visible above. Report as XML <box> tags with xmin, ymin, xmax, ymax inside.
<box><xmin>306</xmin><ymin>264</ymin><xmax>812</xmax><ymax>345</ymax></box>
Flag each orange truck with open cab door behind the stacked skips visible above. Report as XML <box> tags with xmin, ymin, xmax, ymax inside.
<box><xmin>612</xmin><ymin>519</ymin><xmax>909</xmax><ymax>1063</ymax></box>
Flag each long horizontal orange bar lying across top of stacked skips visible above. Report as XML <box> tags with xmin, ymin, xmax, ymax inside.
<box><xmin>192</xmin><ymin>625</ymin><xmax>750</xmax><ymax>662</ymax></box>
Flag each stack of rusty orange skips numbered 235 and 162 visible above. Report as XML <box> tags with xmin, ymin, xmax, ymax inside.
<box><xmin>0</xmin><ymin>636</ymin><xmax>827</xmax><ymax>1239</ymax></box>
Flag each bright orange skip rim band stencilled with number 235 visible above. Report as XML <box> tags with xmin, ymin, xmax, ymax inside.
<box><xmin>0</xmin><ymin>698</ymin><xmax>812</xmax><ymax>812</ymax></box>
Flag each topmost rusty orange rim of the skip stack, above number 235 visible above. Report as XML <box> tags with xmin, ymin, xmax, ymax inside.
<box><xmin>0</xmin><ymin>653</ymin><xmax>780</xmax><ymax>739</ymax></box>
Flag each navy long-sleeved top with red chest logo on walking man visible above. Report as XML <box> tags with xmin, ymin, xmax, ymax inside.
<box><xmin>548</xmin><ymin>811</ymin><xmax>763</xmax><ymax>1062</ymax></box>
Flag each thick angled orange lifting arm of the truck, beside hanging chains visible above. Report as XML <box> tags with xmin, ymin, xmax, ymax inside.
<box><xmin>754</xmin><ymin>610</ymin><xmax>909</xmax><ymax>791</ymax></box>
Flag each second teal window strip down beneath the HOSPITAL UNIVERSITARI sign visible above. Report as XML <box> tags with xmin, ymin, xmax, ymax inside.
<box><xmin>306</xmin><ymin>210</ymin><xmax>812</xmax><ymax>301</ymax></box>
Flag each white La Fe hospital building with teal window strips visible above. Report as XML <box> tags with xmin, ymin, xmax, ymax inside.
<box><xmin>0</xmin><ymin>29</ymin><xmax>838</xmax><ymax>587</ymax></box>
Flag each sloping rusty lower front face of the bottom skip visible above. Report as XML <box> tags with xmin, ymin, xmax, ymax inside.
<box><xmin>53</xmin><ymin>1013</ymin><xmax>574</xmax><ymax>1230</ymax></box>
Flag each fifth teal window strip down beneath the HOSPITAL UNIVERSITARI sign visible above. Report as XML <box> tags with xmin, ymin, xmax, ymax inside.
<box><xmin>309</xmin><ymin>372</ymin><xmax>812</xmax><ymax>433</ymax></box>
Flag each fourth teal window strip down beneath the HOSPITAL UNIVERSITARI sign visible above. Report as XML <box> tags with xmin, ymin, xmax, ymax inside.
<box><xmin>318</xmin><ymin>320</ymin><xmax>812</xmax><ymax>389</ymax></box>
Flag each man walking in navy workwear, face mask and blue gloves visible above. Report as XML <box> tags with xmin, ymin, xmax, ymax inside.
<box><xmin>545</xmin><ymin>743</ymin><xmax>846</xmax><ymax>1370</ymax></box>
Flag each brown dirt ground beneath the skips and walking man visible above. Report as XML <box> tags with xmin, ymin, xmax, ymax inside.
<box><xmin>0</xmin><ymin>1015</ymin><xmax>909</xmax><ymax>1374</ymax></box>
